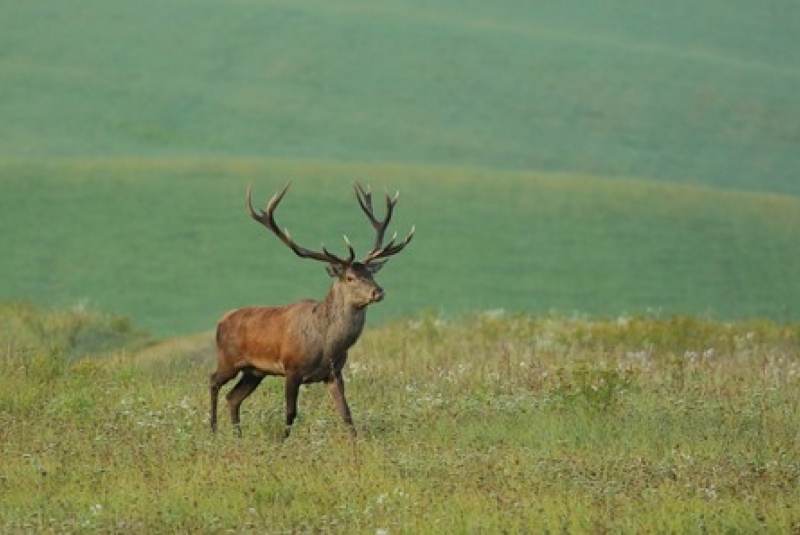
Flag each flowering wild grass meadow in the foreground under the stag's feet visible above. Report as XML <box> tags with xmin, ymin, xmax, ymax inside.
<box><xmin>0</xmin><ymin>304</ymin><xmax>800</xmax><ymax>533</ymax></box>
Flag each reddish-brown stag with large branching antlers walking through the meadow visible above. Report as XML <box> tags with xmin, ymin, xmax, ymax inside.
<box><xmin>209</xmin><ymin>184</ymin><xmax>414</xmax><ymax>437</ymax></box>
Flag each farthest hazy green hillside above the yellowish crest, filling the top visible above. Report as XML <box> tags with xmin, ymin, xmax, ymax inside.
<box><xmin>0</xmin><ymin>0</ymin><xmax>800</xmax><ymax>195</ymax></box>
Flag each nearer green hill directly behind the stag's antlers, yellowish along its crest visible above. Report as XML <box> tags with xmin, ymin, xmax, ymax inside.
<box><xmin>0</xmin><ymin>160</ymin><xmax>800</xmax><ymax>334</ymax></box>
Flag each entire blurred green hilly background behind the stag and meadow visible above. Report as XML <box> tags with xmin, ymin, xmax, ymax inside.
<box><xmin>0</xmin><ymin>0</ymin><xmax>800</xmax><ymax>335</ymax></box>
